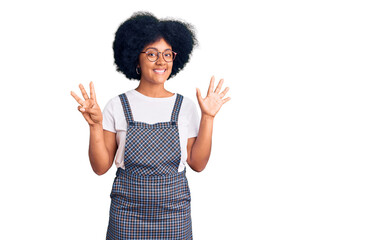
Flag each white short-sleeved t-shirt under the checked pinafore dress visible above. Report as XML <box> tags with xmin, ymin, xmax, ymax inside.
<box><xmin>103</xmin><ymin>89</ymin><xmax>199</xmax><ymax>172</ymax></box>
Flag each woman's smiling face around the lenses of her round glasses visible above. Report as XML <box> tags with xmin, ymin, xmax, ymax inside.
<box><xmin>139</xmin><ymin>38</ymin><xmax>173</xmax><ymax>84</ymax></box>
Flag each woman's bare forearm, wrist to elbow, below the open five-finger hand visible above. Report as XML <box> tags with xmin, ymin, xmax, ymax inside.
<box><xmin>189</xmin><ymin>115</ymin><xmax>214</xmax><ymax>172</ymax></box>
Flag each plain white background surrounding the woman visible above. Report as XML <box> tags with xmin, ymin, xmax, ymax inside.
<box><xmin>0</xmin><ymin>0</ymin><xmax>376</xmax><ymax>240</ymax></box>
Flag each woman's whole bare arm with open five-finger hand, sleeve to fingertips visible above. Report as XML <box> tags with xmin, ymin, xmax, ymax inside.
<box><xmin>187</xmin><ymin>77</ymin><xmax>230</xmax><ymax>172</ymax></box>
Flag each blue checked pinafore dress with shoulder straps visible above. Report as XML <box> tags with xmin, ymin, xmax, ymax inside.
<box><xmin>106</xmin><ymin>93</ymin><xmax>192</xmax><ymax>240</ymax></box>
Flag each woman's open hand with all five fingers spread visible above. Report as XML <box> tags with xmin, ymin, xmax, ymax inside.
<box><xmin>196</xmin><ymin>76</ymin><xmax>230</xmax><ymax>118</ymax></box>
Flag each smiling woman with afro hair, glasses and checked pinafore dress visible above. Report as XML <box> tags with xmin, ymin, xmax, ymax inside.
<box><xmin>71</xmin><ymin>13</ymin><xmax>230</xmax><ymax>239</ymax></box>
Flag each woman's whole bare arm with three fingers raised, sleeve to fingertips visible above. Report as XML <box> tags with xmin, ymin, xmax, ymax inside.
<box><xmin>71</xmin><ymin>82</ymin><xmax>117</xmax><ymax>175</ymax></box>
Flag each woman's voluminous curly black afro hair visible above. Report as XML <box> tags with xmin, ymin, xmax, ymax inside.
<box><xmin>112</xmin><ymin>12</ymin><xmax>197</xmax><ymax>80</ymax></box>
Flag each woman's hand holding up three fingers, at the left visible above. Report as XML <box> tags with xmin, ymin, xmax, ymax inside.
<box><xmin>71</xmin><ymin>82</ymin><xmax>103</xmax><ymax>126</ymax></box>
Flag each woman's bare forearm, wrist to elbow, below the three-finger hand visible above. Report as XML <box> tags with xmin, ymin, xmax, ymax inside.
<box><xmin>89</xmin><ymin>124</ymin><xmax>112</xmax><ymax>175</ymax></box>
